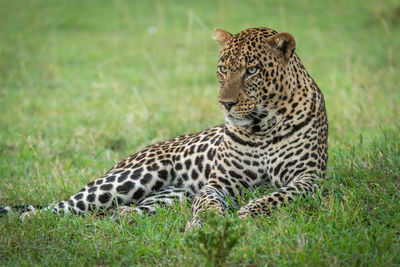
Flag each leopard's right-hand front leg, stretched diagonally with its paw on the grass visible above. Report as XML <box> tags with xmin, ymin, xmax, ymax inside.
<box><xmin>238</xmin><ymin>174</ymin><xmax>318</xmax><ymax>219</ymax></box>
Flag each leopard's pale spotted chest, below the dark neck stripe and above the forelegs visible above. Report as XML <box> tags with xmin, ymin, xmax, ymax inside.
<box><xmin>214</xmin><ymin>134</ymin><xmax>310</xmax><ymax>189</ymax></box>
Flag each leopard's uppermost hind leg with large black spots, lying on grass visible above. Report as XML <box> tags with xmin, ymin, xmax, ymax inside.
<box><xmin>17</xmin><ymin>162</ymin><xmax>177</xmax><ymax>219</ymax></box>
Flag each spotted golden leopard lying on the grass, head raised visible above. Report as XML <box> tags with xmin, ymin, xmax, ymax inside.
<box><xmin>0</xmin><ymin>27</ymin><xmax>328</xmax><ymax>231</ymax></box>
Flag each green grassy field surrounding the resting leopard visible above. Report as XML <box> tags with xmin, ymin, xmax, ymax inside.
<box><xmin>0</xmin><ymin>0</ymin><xmax>400</xmax><ymax>266</ymax></box>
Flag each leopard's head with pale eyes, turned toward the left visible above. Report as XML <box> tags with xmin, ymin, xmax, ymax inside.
<box><xmin>214</xmin><ymin>28</ymin><xmax>297</xmax><ymax>133</ymax></box>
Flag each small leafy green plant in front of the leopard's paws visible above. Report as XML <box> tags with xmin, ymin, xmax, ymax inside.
<box><xmin>185</xmin><ymin>214</ymin><xmax>245</xmax><ymax>266</ymax></box>
